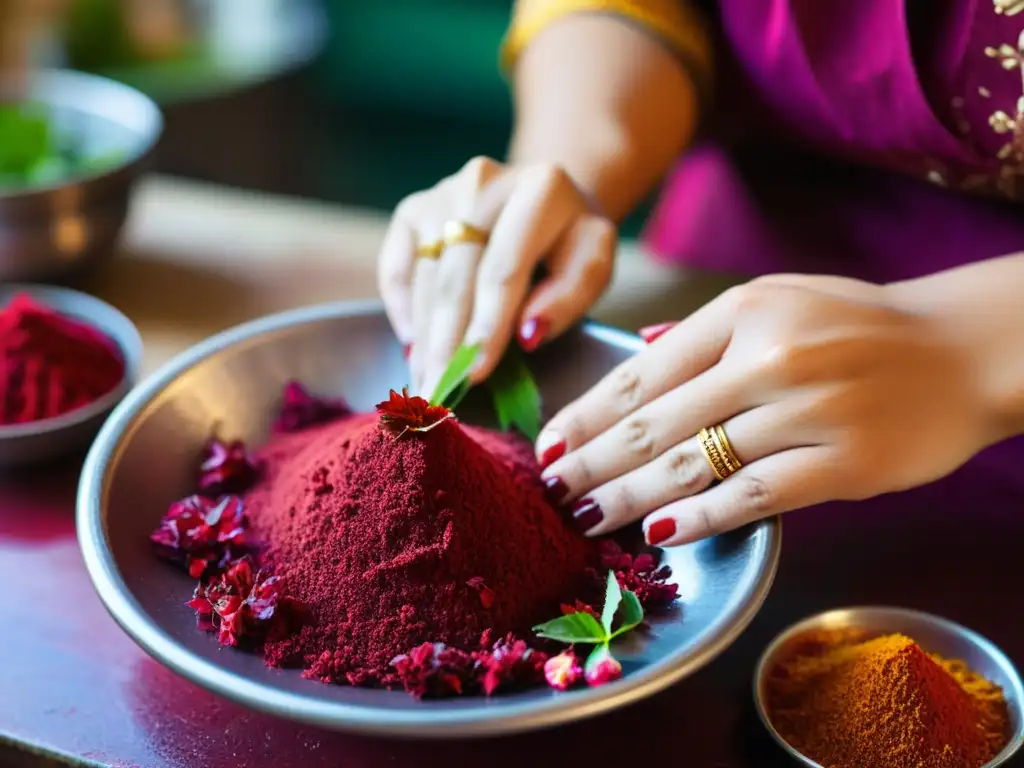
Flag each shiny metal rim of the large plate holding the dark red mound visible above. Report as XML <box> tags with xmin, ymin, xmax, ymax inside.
<box><xmin>76</xmin><ymin>301</ymin><xmax>781</xmax><ymax>738</ymax></box>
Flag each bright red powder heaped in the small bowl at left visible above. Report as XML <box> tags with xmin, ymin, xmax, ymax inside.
<box><xmin>0</xmin><ymin>294</ymin><xmax>125</xmax><ymax>424</ymax></box>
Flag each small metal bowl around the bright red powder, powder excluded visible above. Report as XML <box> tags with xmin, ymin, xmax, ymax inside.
<box><xmin>0</xmin><ymin>284</ymin><xmax>142</xmax><ymax>469</ymax></box>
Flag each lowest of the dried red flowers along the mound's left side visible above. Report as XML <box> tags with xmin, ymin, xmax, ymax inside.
<box><xmin>186</xmin><ymin>557</ymin><xmax>300</xmax><ymax>646</ymax></box>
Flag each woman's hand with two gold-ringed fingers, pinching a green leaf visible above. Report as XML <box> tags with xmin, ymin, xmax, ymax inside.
<box><xmin>379</xmin><ymin>158</ymin><xmax>615</xmax><ymax>395</ymax></box>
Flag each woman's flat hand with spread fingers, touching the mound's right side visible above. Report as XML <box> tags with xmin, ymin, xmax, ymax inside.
<box><xmin>538</xmin><ymin>275</ymin><xmax>998</xmax><ymax>546</ymax></box>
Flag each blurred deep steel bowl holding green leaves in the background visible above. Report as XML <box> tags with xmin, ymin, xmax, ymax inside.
<box><xmin>0</xmin><ymin>71</ymin><xmax>164</xmax><ymax>281</ymax></box>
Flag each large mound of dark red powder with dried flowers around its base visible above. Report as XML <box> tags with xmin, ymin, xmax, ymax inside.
<box><xmin>151</xmin><ymin>382</ymin><xmax>677</xmax><ymax>696</ymax></box>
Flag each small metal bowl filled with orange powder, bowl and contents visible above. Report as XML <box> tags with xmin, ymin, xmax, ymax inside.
<box><xmin>754</xmin><ymin>607</ymin><xmax>1024</xmax><ymax>768</ymax></box>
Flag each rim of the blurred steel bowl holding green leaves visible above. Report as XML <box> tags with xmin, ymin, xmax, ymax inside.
<box><xmin>0</xmin><ymin>68</ymin><xmax>166</xmax><ymax>204</ymax></box>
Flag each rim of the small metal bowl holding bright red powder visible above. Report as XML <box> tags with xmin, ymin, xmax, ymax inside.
<box><xmin>0</xmin><ymin>283</ymin><xmax>142</xmax><ymax>441</ymax></box>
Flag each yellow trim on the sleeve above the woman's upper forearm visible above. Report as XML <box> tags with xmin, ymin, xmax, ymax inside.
<box><xmin>501</xmin><ymin>0</ymin><xmax>711</xmax><ymax>72</ymax></box>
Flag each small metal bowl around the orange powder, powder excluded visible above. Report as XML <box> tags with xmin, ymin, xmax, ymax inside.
<box><xmin>754</xmin><ymin>606</ymin><xmax>1024</xmax><ymax>768</ymax></box>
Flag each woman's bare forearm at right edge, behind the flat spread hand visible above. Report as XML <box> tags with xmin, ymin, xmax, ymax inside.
<box><xmin>890</xmin><ymin>254</ymin><xmax>1024</xmax><ymax>439</ymax></box>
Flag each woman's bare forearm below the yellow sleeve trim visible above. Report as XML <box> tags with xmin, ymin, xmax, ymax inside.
<box><xmin>510</xmin><ymin>13</ymin><xmax>698</xmax><ymax>220</ymax></box>
